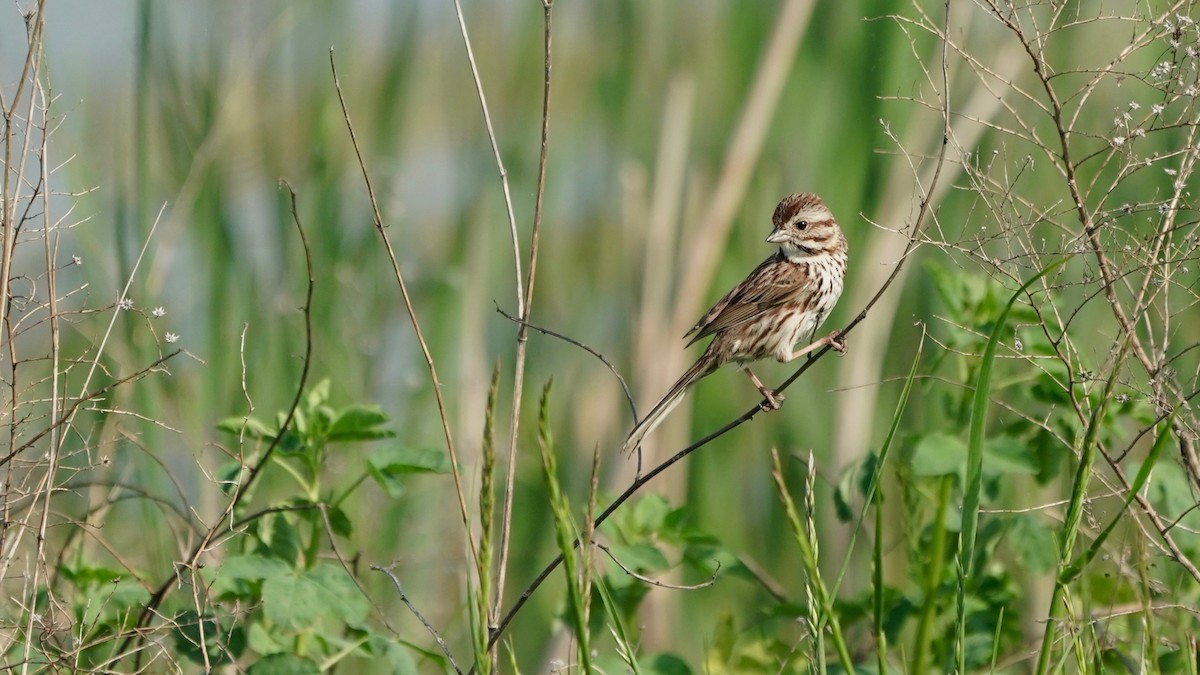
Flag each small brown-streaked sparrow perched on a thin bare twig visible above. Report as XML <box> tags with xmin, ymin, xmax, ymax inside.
<box><xmin>623</xmin><ymin>192</ymin><xmax>848</xmax><ymax>453</ymax></box>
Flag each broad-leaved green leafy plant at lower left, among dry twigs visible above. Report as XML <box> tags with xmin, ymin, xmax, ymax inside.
<box><xmin>192</xmin><ymin>380</ymin><xmax>450</xmax><ymax>673</ymax></box>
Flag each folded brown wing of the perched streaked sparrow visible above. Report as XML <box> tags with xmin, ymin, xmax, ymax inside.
<box><xmin>684</xmin><ymin>253</ymin><xmax>808</xmax><ymax>346</ymax></box>
